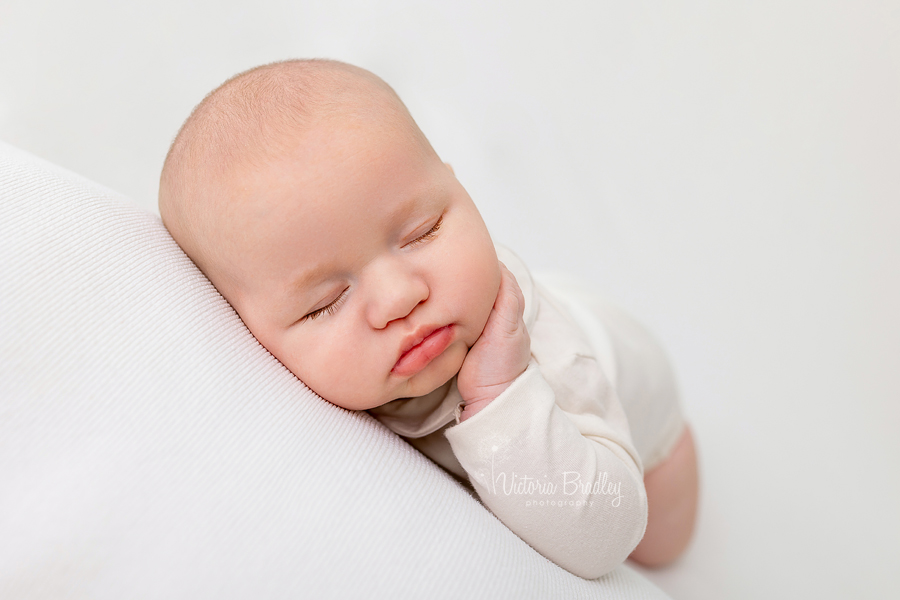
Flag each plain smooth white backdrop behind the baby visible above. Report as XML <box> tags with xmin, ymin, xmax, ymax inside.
<box><xmin>0</xmin><ymin>0</ymin><xmax>900</xmax><ymax>599</ymax></box>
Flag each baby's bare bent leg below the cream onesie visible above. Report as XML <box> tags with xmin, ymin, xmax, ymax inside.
<box><xmin>631</xmin><ymin>427</ymin><xmax>699</xmax><ymax>567</ymax></box>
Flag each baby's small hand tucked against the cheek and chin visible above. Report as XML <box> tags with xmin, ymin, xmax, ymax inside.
<box><xmin>456</xmin><ymin>263</ymin><xmax>531</xmax><ymax>421</ymax></box>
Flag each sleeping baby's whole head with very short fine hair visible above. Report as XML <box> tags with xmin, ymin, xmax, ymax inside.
<box><xmin>159</xmin><ymin>61</ymin><xmax>500</xmax><ymax>410</ymax></box>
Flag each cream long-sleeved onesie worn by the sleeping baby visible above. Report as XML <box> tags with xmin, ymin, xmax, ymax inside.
<box><xmin>369</xmin><ymin>247</ymin><xmax>684</xmax><ymax>578</ymax></box>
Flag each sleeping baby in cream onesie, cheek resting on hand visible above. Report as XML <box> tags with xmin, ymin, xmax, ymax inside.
<box><xmin>159</xmin><ymin>60</ymin><xmax>697</xmax><ymax>578</ymax></box>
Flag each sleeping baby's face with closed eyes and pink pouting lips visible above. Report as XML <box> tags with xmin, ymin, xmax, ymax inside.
<box><xmin>215</xmin><ymin>115</ymin><xmax>500</xmax><ymax>410</ymax></box>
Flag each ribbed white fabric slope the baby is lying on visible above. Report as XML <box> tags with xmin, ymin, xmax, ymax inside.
<box><xmin>0</xmin><ymin>144</ymin><xmax>666</xmax><ymax>599</ymax></box>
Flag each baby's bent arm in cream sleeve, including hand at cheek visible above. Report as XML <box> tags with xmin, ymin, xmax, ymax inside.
<box><xmin>446</xmin><ymin>269</ymin><xmax>647</xmax><ymax>578</ymax></box>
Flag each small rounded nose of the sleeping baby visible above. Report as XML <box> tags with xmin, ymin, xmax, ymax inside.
<box><xmin>368</xmin><ymin>258</ymin><xmax>429</xmax><ymax>329</ymax></box>
